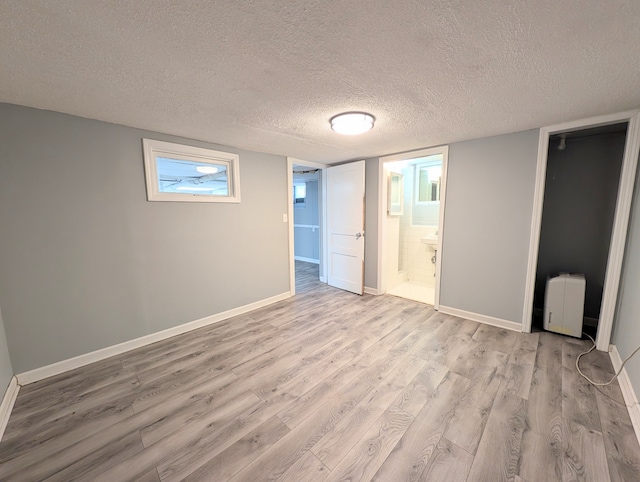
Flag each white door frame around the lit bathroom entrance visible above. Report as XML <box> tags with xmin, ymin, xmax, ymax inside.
<box><xmin>377</xmin><ymin>146</ymin><xmax>449</xmax><ymax>310</ymax></box>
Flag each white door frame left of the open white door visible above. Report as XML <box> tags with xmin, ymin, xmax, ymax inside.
<box><xmin>287</xmin><ymin>157</ymin><xmax>329</xmax><ymax>296</ymax></box>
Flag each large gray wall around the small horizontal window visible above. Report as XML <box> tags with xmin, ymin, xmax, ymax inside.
<box><xmin>0</xmin><ymin>104</ymin><xmax>289</xmax><ymax>373</ymax></box>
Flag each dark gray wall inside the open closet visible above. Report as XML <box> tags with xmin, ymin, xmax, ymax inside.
<box><xmin>534</xmin><ymin>131</ymin><xmax>626</xmax><ymax>319</ymax></box>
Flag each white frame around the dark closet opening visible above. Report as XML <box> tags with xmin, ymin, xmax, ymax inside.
<box><xmin>522</xmin><ymin>109</ymin><xmax>640</xmax><ymax>351</ymax></box>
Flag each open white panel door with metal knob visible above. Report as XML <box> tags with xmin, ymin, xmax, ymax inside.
<box><xmin>327</xmin><ymin>161</ymin><xmax>365</xmax><ymax>295</ymax></box>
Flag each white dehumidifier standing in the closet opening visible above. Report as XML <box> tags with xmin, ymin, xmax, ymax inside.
<box><xmin>544</xmin><ymin>273</ymin><xmax>586</xmax><ymax>338</ymax></box>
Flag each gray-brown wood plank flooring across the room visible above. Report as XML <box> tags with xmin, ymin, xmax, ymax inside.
<box><xmin>0</xmin><ymin>263</ymin><xmax>640</xmax><ymax>482</ymax></box>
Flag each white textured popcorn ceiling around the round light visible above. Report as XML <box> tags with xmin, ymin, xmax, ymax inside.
<box><xmin>0</xmin><ymin>0</ymin><xmax>640</xmax><ymax>163</ymax></box>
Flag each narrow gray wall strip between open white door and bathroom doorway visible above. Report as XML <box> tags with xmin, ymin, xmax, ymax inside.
<box><xmin>364</xmin><ymin>157</ymin><xmax>380</xmax><ymax>289</ymax></box>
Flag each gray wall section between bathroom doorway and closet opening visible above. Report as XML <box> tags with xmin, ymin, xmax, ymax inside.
<box><xmin>440</xmin><ymin>130</ymin><xmax>538</xmax><ymax>323</ymax></box>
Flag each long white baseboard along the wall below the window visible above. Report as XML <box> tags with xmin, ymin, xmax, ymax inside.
<box><xmin>16</xmin><ymin>291</ymin><xmax>291</xmax><ymax>385</ymax></box>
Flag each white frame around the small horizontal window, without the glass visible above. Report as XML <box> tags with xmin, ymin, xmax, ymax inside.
<box><xmin>142</xmin><ymin>139</ymin><xmax>240</xmax><ymax>203</ymax></box>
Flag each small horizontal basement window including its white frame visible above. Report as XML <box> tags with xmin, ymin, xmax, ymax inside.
<box><xmin>142</xmin><ymin>139</ymin><xmax>240</xmax><ymax>203</ymax></box>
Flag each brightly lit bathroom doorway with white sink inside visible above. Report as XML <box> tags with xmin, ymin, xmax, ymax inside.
<box><xmin>378</xmin><ymin>147</ymin><xmax>448</xmax><ymax>308</ymax></box>
